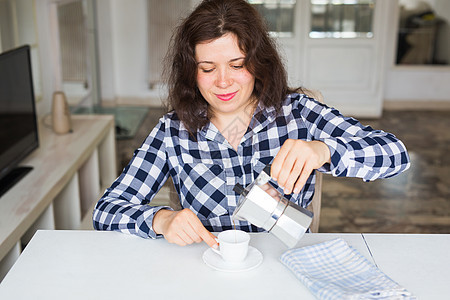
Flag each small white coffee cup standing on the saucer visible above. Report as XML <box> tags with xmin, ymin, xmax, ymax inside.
<box><xmin>212</xmin><ymin>229</ymin><xmax>250</xmax><ymax>263</ymax></box>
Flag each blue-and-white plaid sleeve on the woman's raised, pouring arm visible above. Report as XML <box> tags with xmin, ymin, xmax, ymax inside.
<box><xmin>299</xmin><ymin>97</ymin><xmax>410</xmax><ymax>181</ymax></box>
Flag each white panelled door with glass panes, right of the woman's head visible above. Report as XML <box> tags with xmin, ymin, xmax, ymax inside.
<box><xmin>278</xmin><ymin>0</ymin><xmax>395</xmax><ymax>117</ymax></box>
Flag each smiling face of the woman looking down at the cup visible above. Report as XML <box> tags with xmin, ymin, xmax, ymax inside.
<box><xmin>195</xmin><ymin>33</ymin><xmax>255</xmax><ymax>117</ymax></box>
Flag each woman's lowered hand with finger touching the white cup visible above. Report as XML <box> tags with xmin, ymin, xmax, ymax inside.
<box><xmin>153</xmin><ymin>208</ymin><xmax>217</xmax><ymax>248</ymax></box>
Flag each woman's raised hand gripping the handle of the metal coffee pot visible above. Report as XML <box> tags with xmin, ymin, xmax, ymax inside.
<box><xmin>270</xmin><ymin>139</ymin><xmax>330</xmax><ymax>194</ymax></box>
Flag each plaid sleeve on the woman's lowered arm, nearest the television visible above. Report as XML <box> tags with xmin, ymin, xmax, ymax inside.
<box><xmin>93</xmin><ymin>119</ymin><xmax>171</xmax><ymax>238</ymax></box>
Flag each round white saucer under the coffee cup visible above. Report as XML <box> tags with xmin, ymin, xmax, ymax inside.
<box><xmin>203</xmin><ymin>246</ymin><xmax>263</xmax><ymax>272</ymax></box>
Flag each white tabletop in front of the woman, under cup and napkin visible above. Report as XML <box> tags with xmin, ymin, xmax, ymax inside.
<box><xmin>0</xmin><ymin>231</ymin><xmax>450</xmax><ymax>300</ymax></box>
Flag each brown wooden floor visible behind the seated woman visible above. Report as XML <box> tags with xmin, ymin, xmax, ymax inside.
<box><xmin>117</xmin><ymin>108</ymin><xmax>450</xmax><ymax>233</ymax></box>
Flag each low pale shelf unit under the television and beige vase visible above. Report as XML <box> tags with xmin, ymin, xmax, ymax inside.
<box><xmin>0</xmin><ymin>115</ymin><xmax>117</xmax><ymax>280</ymax></box>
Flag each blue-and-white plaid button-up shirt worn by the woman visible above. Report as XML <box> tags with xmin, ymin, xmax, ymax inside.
<box><xmin>93</xmin><ymin>94</ymin><xmax>409</xmax><ymax>238</ymax></box>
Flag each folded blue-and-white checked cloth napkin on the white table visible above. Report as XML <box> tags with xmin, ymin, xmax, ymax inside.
<box><xmin>280</xmin><ymin>239</ymin><xmax>416</xmax><ymax>299</ymax></box>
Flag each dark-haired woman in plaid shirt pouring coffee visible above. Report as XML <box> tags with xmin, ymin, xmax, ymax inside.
<box><xmin>93</xmin><ymin>0</ymin><xmax>409</xmax><ymax>247</ymax></box>
